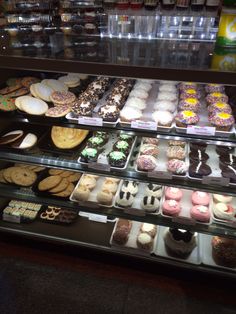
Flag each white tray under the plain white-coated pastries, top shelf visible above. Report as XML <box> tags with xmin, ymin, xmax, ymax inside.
<box><xmin>120</xmin><ymin>83</ymin><xmax>176</xmax><ymax>132</ymax></box>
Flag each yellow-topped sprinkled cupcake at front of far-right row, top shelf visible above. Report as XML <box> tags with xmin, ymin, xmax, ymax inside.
<box><xmin>209</xmin><ymin>112</ymin><xmax>235</xmax><ymax>131</ymax></box>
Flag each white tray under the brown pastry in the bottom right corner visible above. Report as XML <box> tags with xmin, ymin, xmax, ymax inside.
<box><xmin>200</xmin><ymin>234</ymin><xmax>236</xmax><ymax>271</ymax></box>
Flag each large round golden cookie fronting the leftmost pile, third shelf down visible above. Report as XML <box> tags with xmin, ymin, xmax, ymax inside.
<box><xmin>11</xmin><ymin>168</ymin><xmax>37</xmax><ymax>186</ymax></box>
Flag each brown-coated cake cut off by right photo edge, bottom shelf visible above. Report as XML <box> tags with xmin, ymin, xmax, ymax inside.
<box><xmin>211</xmin><ymin>236</ymin><xmax>236</xmax><ymax>267</ymax></box>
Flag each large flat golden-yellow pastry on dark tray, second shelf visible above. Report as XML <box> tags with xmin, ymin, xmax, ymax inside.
<box><xmin>51</xmin><ymin>126</ymin><xmax>89</xmax><ymax>149</ymax></box>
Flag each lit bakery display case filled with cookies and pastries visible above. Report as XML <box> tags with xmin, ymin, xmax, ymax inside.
<box><xmin>0</xmin><ymin>1</ymin><xmax>236</xmax><ymax>279</ymax></box>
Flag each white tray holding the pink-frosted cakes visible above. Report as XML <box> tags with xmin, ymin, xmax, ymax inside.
<box><xmin>160</xmin><ymin>189</ymin><xmax>212</xmax><ymax>225</ymax></box>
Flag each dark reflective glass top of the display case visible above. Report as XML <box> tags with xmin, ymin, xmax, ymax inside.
<box><xmin>0</xmin><ymin>33</ymin><xmax>236</xmax><ymax>85</ymax></box>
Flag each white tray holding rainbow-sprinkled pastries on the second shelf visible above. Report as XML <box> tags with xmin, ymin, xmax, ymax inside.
<box><xmin>135</xmin><ymin>138</ymin><xmax>189</xmax><ymax>179</ymax></box>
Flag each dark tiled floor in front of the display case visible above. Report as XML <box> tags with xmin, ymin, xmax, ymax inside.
<box><xmin>0</xmin><ymin>250</ymin><xmax>236</xmax><ymax>314</ymax></box>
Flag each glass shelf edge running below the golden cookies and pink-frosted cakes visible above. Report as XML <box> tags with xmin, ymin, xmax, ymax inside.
<box><xmin>0</xmin><ymin>184</ymin><xmax>236</xmax><ymax>238</ymax></box>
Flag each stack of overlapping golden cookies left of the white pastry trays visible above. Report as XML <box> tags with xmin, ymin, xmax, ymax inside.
<box><xmin>38</xmin><ymin>169</ymin><xmax>81</xmax><ymax>198</ymax></box>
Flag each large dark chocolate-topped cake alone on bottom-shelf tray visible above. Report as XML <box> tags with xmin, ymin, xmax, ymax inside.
<box><xmin>163</xmin><ymin>228</ymin><xmax>197</xmax><ymax>258</ymax></box>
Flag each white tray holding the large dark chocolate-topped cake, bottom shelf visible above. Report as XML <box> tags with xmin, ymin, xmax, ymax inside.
<box><xmin>154</xmin><ymin>227</ymin><xmax>201</xmax><ymax>265</ymax></box>
